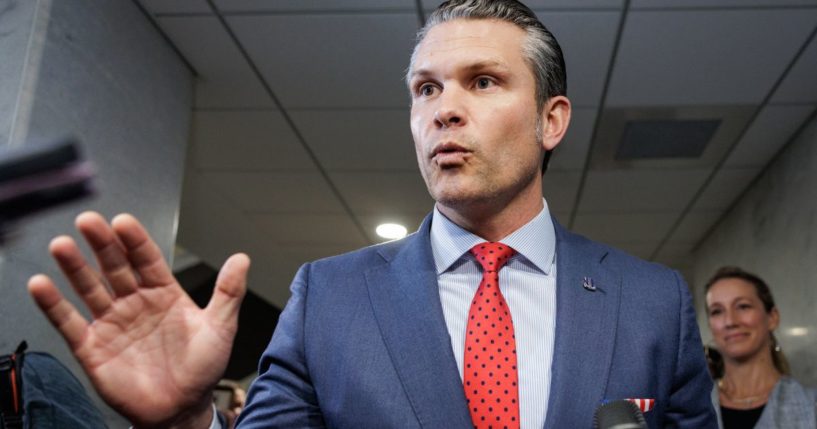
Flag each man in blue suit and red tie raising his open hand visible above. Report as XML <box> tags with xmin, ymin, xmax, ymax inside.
<box><xmin>29</xmin><ymin>0</ymin><xmax>716</xmax><ymax>428</ymax></box>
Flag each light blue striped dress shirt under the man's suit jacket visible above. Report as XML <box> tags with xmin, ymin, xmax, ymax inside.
<box><xmin>431</xmin><ymin>201</ymin><xmax>556</xmax><ymax>429</ymax></box>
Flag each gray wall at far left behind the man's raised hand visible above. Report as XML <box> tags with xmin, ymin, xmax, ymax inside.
<box><xmin>0</xmin><ymin>0</ymin><xmax>192</xmax><ymax>427</ymax></box>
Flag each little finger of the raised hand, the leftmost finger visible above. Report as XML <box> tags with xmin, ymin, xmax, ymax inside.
<box><xmin>28</xmin><ymin>274</ymin><xmax>88</xmax><ymax>350</ymax></box>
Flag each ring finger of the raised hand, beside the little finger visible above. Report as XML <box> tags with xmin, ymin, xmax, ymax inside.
<box><xmin>48</xmin><ymin>236</ymin><xmax>112</xmax><ymax>317</ymax></box>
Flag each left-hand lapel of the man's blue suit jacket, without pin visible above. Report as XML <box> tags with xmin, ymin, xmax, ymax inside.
<box><xmin>365</xmin><ymin>216</ymin><xmax>471</xmax><ymax>428</ymax></box>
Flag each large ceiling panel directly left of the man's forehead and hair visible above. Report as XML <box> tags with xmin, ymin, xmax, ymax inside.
<box><xmin>227</xmin><ymin>13</ymin><xmax>417</xmax><ymax>108</ymax></box>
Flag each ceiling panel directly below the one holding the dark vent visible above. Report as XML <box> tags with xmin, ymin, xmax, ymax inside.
<box><xmin>578</xmin><ymin>169</ymin><xmax>709</xmax><ymax>214</ymax></box>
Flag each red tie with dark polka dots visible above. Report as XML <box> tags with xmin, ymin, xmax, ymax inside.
<box><xmin>463</xmin><ymin>243</ymin><xmax>519</xmax><ymax>429</ymax></box>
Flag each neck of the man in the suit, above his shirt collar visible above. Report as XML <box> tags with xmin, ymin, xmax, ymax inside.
<box><xmin>437</xmin><ymin>187</ymin><xmax>544</xmax><ymax>241</ymax></box>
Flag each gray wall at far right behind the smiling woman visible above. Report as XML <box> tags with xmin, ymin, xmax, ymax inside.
<box><xmin>694</xmin><ymin>109</ymin><xmax>817</xmax><ymax>386</ymax></box>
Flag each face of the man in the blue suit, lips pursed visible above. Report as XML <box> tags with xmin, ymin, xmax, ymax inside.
<box><xmin>409</xmin><ymin>19</ymin><xmax>555</xmax><ymax>212</ymax></box>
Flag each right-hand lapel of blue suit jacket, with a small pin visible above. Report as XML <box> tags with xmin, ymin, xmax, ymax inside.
<box><xmin>545</xmin><ymin>220</ymin><xmax>621</xmax><ymax>428</ymax></box>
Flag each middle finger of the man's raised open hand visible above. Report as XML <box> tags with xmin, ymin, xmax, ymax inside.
<box><xmin>76</xmin><ymin>212</ymin><xmax>139</xmax><ymax>296</ymax></box>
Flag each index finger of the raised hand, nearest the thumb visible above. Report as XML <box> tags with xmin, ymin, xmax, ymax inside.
<box><xmin>111</xmin><ymin>214</ymin><xmax>176</xmax><ymax>287</ymax></box>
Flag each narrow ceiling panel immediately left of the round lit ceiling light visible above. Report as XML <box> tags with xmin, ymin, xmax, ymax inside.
<box><xmin>248</xmin><ymin>214</ymin><xmax>369</xmax><ymax>248</ymax></box>
